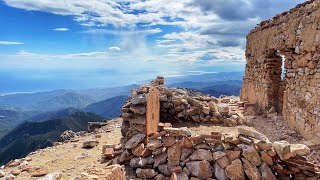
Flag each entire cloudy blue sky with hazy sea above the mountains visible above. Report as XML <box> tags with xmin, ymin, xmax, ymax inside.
<box><xmin>0</xmin><ymin>0</ymin><xmax>303</xmax><ymax>92</ymax></box>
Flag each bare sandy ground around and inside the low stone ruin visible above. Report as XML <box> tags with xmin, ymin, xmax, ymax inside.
<box><xmin>0</xmin><ymin>97</ymin><xmax>320</xmax><ymax>180</ymax></box>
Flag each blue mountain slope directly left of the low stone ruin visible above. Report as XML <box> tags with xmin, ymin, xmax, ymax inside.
<box><xmin>83</xmin><ymin>96</ymin><xmax>128</xmax><ymax>118</ymax></box>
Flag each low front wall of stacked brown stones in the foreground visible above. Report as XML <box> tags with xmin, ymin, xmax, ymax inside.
<box><xmin>103</xmin><ymin>123</ymin><xmax>319</xmax><ymax>180</ymax></box>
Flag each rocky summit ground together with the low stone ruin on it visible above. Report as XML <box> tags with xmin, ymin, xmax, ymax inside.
<box><xmin>0</xmin><ymin>78</ymin><xmax>320</xmax><ymax>180</ymax></box>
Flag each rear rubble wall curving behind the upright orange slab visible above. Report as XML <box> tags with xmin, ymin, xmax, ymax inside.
<box><xmin>121</xmin><ymin>77</ymin><xmax>244</xmax><ymax>138</ymax></box>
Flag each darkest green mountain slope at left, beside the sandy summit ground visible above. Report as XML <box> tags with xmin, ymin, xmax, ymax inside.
<box><xmin>0</xmin><ymin>112</ymin><xmax>104</xmax><ymax>164</ymax></box>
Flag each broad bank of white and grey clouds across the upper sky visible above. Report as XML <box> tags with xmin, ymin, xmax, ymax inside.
<box><xmin>3</xmin><ymin>0</ymin><xmax>303</xmax><ymax>66</ymax></box>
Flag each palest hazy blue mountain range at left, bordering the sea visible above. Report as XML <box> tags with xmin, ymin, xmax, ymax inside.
<box><xmin>0</xmin><ymin>84</ymin><xmax>138</xmax><ymax>111</ymax></box>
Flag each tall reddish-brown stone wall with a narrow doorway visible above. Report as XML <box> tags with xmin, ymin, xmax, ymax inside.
<box><xmin>240</xmin><ymin>0</ymin><xmax>320</xmax><ymax>143</ymax></box>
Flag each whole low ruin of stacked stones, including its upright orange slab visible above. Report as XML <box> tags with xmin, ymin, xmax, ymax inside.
<box><xmin>102</xmin><ymin>77</ymin><xmax>319</xmax><ymax>180</ymax></box>
